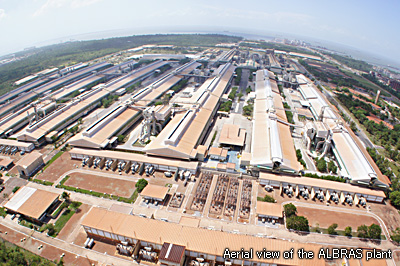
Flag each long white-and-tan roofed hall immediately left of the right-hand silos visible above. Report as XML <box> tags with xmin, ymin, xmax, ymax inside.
<box><xmin>250</xmin><ymin>70</ymin><xmax>302</xmax><ymax>173</ymax></box>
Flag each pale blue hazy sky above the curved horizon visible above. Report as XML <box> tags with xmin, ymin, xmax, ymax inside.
<box><xmin>0</xmin><ymin>0</ymin><xmax>400</xmax><ymax>63</ymax></box>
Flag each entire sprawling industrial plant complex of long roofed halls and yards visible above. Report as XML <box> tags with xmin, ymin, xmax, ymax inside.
<box><xmin>0</xmin><ymin>35</ymin><xmax>400</xmax><ymax>266</ymax></box>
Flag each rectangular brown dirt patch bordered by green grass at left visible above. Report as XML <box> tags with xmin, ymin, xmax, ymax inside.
<box><xmin>64</xmin><ymin>173</ymin><xmax>136</xmax><ymax>198</ymax></box>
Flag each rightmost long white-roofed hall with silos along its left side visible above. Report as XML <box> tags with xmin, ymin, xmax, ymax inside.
<box><xmin>297</xmin><ymin>75</ymin><xmax>390</xmax><ymax>188</ymax></box>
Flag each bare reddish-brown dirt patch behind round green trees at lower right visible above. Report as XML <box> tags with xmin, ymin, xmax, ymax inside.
<box><xmin>296</xmin><ymin>205</ymin><xmax>380</xmax><ymax>231</ymax></box>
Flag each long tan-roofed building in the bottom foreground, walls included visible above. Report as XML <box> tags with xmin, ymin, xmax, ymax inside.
<box><xmin>81</xmin><ymin>207</ymin><xmax>325</xmax><ymax>266</ymax></box>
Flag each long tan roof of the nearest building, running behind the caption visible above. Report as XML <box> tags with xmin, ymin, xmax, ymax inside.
<box><xmin>81</xmin><ymin>207</ymin><xmax>325</xmax><ymax>266</ymax></box>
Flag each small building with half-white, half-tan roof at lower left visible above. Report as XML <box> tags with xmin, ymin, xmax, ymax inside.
<box><xmin>4</xmin><ymin>187</ymin><xmax>60</xmax><ymax>224</ymax></box>
